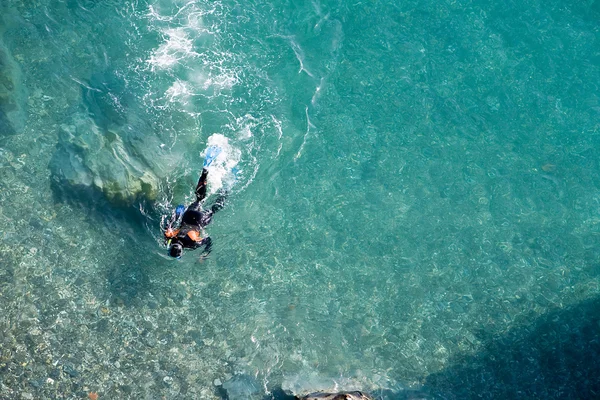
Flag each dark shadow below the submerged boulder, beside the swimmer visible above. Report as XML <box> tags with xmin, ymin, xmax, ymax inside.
<box><xmin>51</xmin><ymin>170</ymin><xmax>209</xmax><ymax>309</ymax></box>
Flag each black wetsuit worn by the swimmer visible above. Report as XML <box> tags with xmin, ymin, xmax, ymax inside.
<box><xmin>164</xmin><ymin>168</ymin><xmax>225</xmax><ymax>254</ymax></box>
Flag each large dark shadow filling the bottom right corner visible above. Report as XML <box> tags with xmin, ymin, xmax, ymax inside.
<box><xmin>425</xmin><ymin>298</ymin><xmax>600</xmax><ymax>399</ymax></box>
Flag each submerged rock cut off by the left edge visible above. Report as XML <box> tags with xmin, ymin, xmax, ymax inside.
<box><xmin>0</xmin><ymin>20</ymin><xmax>27</xmax><ymax>137</ymax></box>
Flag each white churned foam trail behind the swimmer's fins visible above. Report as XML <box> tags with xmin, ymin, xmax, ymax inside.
<box><xmin>144</xmin><ymin>0</ymin><xmax>282</xmax><ymax>198</ymax></box>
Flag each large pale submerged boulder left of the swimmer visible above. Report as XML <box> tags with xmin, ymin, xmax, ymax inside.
<box><xmin>50</xmin><ymin>114</ymin><xmax>164</xmax><ymax>206</ymax></box>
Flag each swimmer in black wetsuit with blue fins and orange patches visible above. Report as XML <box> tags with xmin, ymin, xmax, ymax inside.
<box><xmin>164</xmin><ymin>148</ymin><xmax>226</xmax><ymax>258</ymax></box>
